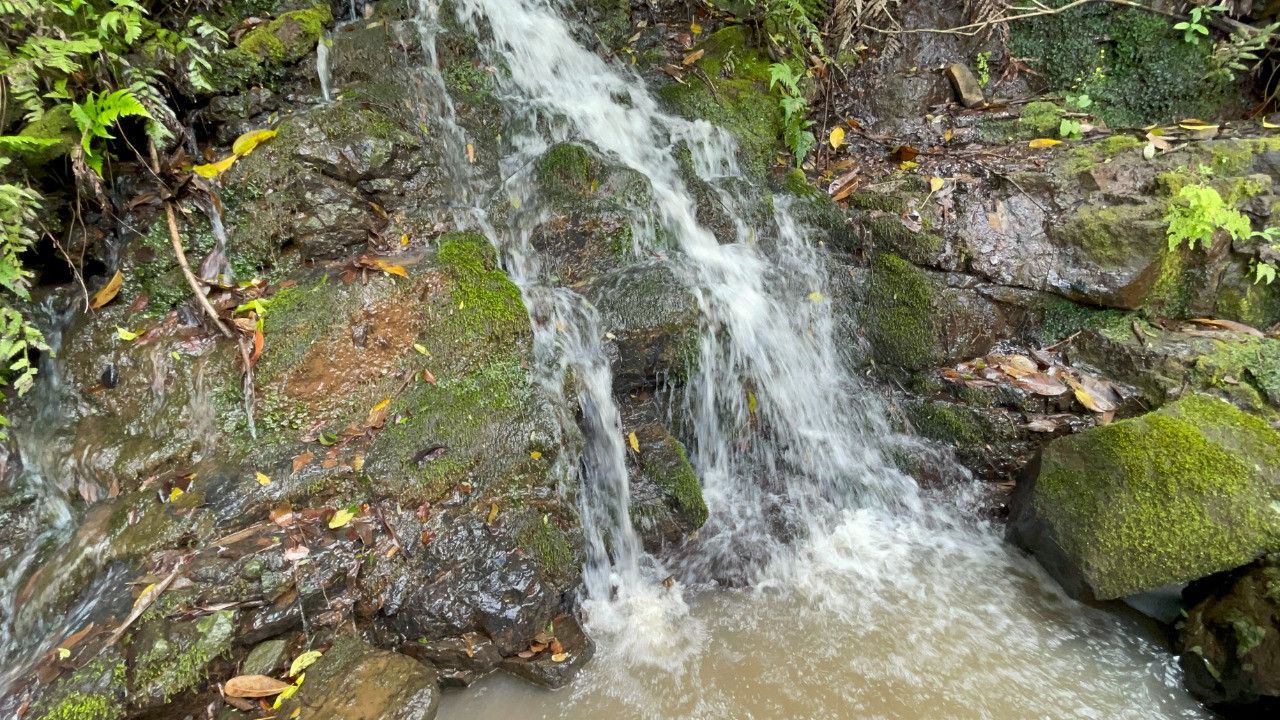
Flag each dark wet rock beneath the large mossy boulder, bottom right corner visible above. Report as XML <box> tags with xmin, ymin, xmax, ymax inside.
<box><xmin>1178</xmin><ymin>555</ymin><xmax>1280</xmax><ymax>717</ymax></box>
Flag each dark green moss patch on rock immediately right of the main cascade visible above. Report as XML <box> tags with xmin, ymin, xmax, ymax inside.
<box><xmin>865</xmin><ymin>252</ymin><xmax>941</xmax><ymax>370</ymax></box>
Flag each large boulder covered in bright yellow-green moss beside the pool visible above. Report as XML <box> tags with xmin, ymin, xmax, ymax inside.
<box><xmin>1014</xmin><ymin>396</ymin><xmax>1280</xmax><ymax>600</ymax></box>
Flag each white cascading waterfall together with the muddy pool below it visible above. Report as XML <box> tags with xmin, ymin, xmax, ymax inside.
<box><xmin>407</xmin><ymin>0</ymin><xmax>1208</xmax><ymax>719</ymax></box>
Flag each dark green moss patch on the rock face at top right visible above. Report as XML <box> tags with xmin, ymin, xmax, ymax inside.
<box><xmin>1010</xmin><ymin>0</ymin><xmax>1226</xmax><ymax>131</ymax></box>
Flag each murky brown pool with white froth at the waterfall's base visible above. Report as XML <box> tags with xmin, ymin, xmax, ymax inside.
<box><xmin>440</xmin><ymin>514</ymin><xmax>1212</xmax><ymax>720</ymax></box>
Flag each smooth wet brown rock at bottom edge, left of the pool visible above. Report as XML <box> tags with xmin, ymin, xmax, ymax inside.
<box><xmin>282</xmin><ymin>637</ymin><xmax>440</xmax><ymax>720</ymax></box>
